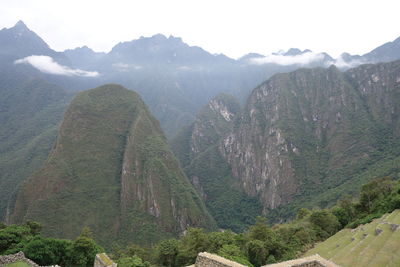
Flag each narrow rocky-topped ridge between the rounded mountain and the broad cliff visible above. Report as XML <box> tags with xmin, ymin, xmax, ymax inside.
<box><xmin>172</xmin><ymin>94</ymin><xmax>262</xmax><ymax>232</ymax></box>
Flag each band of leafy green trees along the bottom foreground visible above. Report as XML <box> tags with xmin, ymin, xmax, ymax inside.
<box><xmin>0</xmin><ymin>177</ymin><xmax>400</xmax><ymax>267</ymax></box>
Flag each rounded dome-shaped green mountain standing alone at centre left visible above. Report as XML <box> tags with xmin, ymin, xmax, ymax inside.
<box><xmin>12</xmin><ymin>84</ymin><xmax>215</xmax><ymax>246</ymax></box>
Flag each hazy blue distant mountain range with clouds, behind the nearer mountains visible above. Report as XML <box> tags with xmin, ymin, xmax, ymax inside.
<box><xmin>0</xmin><ymin>21</ymin><xmax>400</xmax><ymax>137</ymax></box>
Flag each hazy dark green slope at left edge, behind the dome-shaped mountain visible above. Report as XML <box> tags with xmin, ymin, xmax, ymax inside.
<box><xmin>0</xmin><ymin>71</ymin><xmax>71</xmax><ymax>220</ymax></box>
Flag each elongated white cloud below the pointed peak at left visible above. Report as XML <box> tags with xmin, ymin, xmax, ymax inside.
<box><xmin>14</xmin><ymin>55</ymin><xmax>99</xmax><ymax>77</ymax></box>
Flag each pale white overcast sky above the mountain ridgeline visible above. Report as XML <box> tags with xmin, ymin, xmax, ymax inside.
<box><xmin>0</xmin><ymin>0</ymin><xmax>400</xmax><ymax>58</ymax></box>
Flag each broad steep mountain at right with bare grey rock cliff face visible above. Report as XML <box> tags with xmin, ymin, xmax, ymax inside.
<box><xmin>219</xmin><ymin>62</ymin><xmax>400</xmax><ymax>216</ymax></box>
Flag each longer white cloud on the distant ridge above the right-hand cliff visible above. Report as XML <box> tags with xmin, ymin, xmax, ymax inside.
<box><xmin>249</xmin><ymin>52</ymin><xmax>324</xmax><ymax>66</ymax></box>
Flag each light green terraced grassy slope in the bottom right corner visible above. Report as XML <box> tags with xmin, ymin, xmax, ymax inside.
<box><xmin>306</xmin><ymin>210</ymin><xmax>400</xmax><ymax>267</ymax></box>
